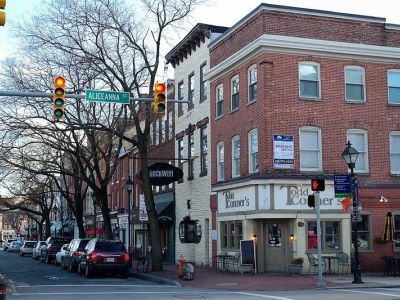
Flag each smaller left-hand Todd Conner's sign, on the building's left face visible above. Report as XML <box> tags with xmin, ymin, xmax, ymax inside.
<box><xmin>218</xmin><ymin>186</ymin><xmax>256</xmax><ymax>213</ymax></box>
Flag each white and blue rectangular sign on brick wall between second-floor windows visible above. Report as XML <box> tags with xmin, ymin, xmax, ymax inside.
<box><xmin>274</xmin><ymin>135</ymin><xmax>294</xmax><ymax>169</ymax></box>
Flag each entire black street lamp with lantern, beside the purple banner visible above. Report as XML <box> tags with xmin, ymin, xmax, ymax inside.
<box><xmin>342</xmin><ymin>141</ymin><xmax>364</xmax><ymax>283</ymax></box>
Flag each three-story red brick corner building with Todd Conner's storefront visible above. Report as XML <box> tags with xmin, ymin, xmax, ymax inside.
<box><xmin>206</xmin><ymin>4</ymin><xmax>400</xmax><ymax>272</ymax></box>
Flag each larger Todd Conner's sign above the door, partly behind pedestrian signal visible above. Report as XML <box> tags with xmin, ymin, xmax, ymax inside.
<box><xmin>274</xmin><ymin>184</ymin><xmax>343</xmax><ymax>210</ymax></box>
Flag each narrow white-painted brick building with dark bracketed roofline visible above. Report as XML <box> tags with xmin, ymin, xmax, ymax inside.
<box><xmin>166</xmin><ymin>24</ymin><xmax>227</xmax><ymax>265</ymax></box>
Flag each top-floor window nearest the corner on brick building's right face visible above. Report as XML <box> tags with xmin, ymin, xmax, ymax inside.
<box><xmin>299</xmin><ymin>62</ymin><xmax>321</xmax><ymax>99</ymax></box>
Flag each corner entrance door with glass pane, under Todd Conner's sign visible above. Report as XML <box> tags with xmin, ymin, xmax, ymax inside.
<box><xmin>264</xmin><ymin>221</ymin><xmax>288</xmax><ymax>272</ymax></box>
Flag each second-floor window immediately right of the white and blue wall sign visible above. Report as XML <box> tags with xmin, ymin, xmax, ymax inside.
<box><xmin>300</xmin><ymin>127</ymin><xmax>322</xmax><ymax>171</ymax></box>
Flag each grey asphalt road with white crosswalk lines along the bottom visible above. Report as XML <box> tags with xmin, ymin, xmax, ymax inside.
<box><xmin>0</xmin><ymin>251</ymin><xmax>400</xmax><ymax>300</ymax></box>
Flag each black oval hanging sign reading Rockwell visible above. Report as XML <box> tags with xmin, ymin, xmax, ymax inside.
<box><xmin>140</xmin><ymin>163</ymin><xmax>183</xmax><ymax>186</ymax></box>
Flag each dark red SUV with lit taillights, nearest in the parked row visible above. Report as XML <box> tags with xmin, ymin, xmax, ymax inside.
<box><xmin>78</xmin><ymin>239</ymin><xmax>129</xmax><ymax>278</ymax></box>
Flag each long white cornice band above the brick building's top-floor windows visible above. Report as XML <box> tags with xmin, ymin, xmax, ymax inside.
<box><xmin>205</xmin><ymin>34</ymin><xmax>400</xmax><ymax>81</ymax></box>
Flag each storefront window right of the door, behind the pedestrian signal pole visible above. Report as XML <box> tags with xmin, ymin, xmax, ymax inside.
<box><xmin>307</xmin><ymin>221</ymin><xmax>341</xmax><ymax>252</ymax></box>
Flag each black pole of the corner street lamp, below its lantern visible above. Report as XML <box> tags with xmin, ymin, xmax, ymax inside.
<box><xmin>350</xmin><ymin>164</ymin><xmax>364</xmax><ymax>284</ymax></box>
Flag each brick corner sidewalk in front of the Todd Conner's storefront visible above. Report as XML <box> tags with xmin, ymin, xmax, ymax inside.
<box><xmin>131</xmin><ymin>264</ymin><xmax>400</xmax><ymax>291</ymax></box>
